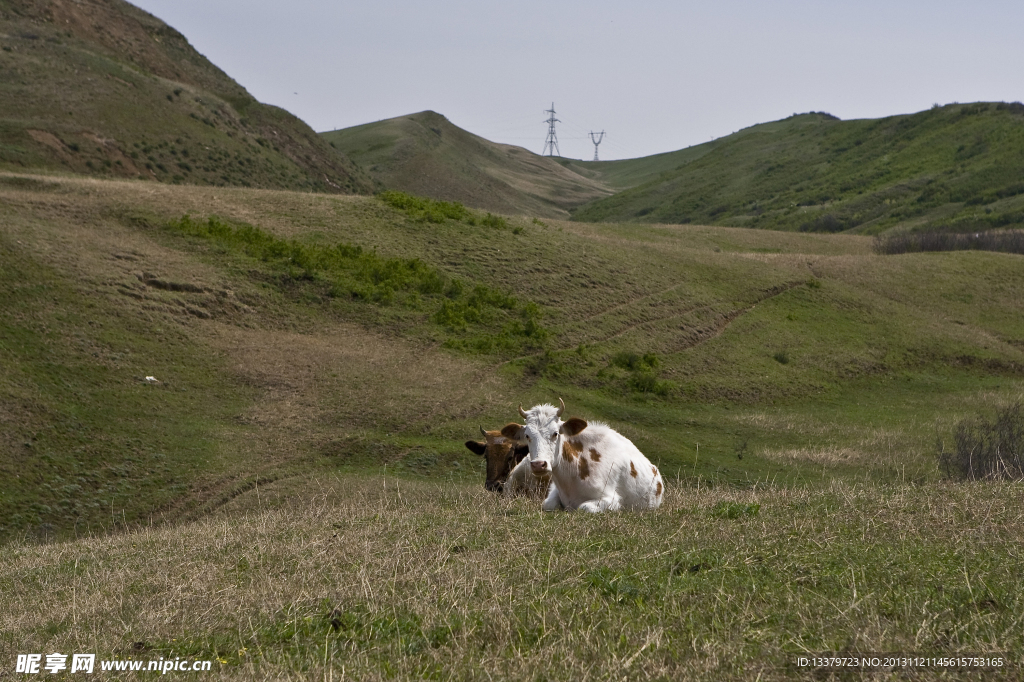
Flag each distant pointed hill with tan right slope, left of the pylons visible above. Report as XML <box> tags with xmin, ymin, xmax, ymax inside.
<box><xmin>321</xmin><ymin>112</ymin><xmax>610</xmax><ymax>218</ymax></box>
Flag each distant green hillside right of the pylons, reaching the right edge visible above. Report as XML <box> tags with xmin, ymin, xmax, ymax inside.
<box><xmin>573</xmin><ymin>102</ymin><xmax>1024</xmax><ymax>235</ymax></box>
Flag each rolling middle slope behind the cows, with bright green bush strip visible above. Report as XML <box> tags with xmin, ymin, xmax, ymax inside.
<box><xmin>0</xmin><ymin>174</ymin><xmax>1024</xmax><ymax>537</ymax></box>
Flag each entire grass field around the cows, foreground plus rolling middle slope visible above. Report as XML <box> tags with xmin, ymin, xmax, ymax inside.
<box><xmin>0</xmin><ymin>173</ymin><xmax>1024</xmax><ymax>680</ymax></box>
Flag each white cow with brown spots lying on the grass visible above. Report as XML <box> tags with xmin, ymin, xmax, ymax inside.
<box><xmin>502</xmin><ymin>398</ymin><xmax>665</xmax><ymax>512</ymax></box>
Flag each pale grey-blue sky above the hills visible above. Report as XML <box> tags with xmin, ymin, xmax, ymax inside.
<box><xmin>134</xmin><ymin>0</ymin><xmax>1024</xmax><ymax>160</ymax></box>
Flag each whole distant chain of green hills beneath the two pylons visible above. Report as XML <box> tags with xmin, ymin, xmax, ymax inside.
<box><xmin>322</xmin><ymin>102</ymin><xmax>1024</xmax><ymax>235</ymax></box>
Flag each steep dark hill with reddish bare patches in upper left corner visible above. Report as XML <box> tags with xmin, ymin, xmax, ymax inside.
<box><xmin>0</xmin><ymin>0</ymin><xmax>372</xmax><ymax>193</ymax></box>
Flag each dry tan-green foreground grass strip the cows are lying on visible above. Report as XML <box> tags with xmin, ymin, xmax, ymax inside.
<box><xmin>0</xmin><ymin>476</ymin><xmax>1024</xmax><ymax>680</ymax></box>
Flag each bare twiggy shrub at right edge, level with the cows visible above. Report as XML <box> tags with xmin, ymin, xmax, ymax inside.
<box><xmin>938</xmin><ymin>402</ymin><xmax>1024</xmax><ymax>480</ymax></box>
